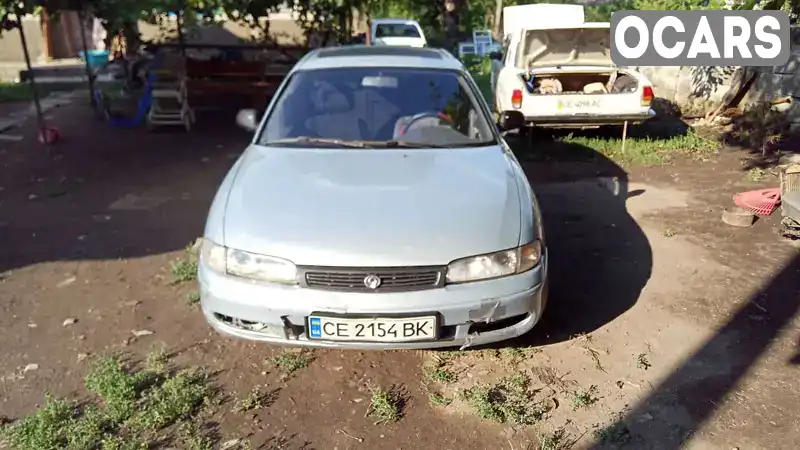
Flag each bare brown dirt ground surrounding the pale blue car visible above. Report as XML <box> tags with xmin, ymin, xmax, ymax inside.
<box><xmin>0</xmin><ymin>101</ymin><xmax>800</xmax><ymax>450</ymax></box>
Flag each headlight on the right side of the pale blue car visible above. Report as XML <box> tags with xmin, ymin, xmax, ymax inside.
<box><xmin>447</xmin><ymin>240</ymin><xmax>542</xmax><ymax>284</ymax></box>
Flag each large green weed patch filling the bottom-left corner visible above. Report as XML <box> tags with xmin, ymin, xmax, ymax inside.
<box><xmin>0</xmin><ymin>352</ymin><xmax>213</xmax><ymax>450</ymax></box>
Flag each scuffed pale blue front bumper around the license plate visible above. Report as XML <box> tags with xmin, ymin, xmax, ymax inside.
<box><xmin>199</xmin><ymin>252</ymin><xmax>547</xmax><ymax>349</ymax></box>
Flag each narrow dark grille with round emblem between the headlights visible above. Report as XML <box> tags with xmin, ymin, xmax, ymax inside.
<box><xmin>301</xmin><ymin>267</ymin><xmax>444</xmax><ymax>292</ymax></box>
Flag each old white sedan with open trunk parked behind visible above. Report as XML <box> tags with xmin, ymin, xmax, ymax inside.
<box><xmin>490</xmin><ymin>4</ymin><xmax>655</xmax><ymax>129</ymax></box>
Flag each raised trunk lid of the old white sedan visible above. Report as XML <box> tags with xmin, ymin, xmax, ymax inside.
<box><xmin>517</xmin><ymin>22</ymin><xmax>613</xmax><ymax>69</ymax></box>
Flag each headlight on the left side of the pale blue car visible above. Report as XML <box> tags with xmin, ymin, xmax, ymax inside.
<box><xmin>200</xmin><ymin>239</ymin><xmax>297</xmax><ymax>284</ymax></box>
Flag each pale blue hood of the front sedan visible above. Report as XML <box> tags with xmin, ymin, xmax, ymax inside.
<box><xmin>223</xmin><ymin>146</ymin><xmax>521</xmax><ymax>267</ymax></box>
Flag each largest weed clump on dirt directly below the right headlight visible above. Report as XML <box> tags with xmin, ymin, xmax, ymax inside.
<box><xmin>461</xmin><ymin>374</ymin><xmax>548</xmax><ymax>426</ymax></box>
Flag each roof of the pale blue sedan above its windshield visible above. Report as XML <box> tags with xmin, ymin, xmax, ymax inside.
<box><xmin>291</xmin><ymin>45</ymin><xmax>465</xmax><ymax>73</ymax></box>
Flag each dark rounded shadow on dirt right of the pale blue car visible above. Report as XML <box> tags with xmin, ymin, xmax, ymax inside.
<box><xmin>507</xmin><ymin>132</ymin><xmax>653</xmax><ymax>346</ymax></box>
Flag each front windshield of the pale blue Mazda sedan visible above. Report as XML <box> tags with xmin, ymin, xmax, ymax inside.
<box><xmin>258</xmin><ymin>67</ymin><xmax>496</xmax><ymax>148</ymax></box>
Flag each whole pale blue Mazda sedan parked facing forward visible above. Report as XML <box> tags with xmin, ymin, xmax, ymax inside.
<box><xmin>198</xmin><ymin>46</ymin><xmax>548</xmax><ymax>349</ymax></box>
